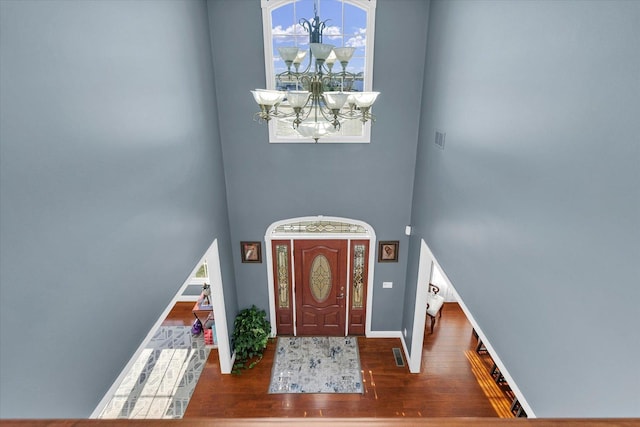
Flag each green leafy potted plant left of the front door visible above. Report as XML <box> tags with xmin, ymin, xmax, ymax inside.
<box><xmin>232</xmin><ymin>305</ymin><xmax>271</xmax><ymax>374</ymax></box>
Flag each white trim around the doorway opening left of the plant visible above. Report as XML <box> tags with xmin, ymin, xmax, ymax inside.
<box><xmin>89</xmin><ymin>239</ymin><xmax>233</xmax><ymax>418</ymax></box>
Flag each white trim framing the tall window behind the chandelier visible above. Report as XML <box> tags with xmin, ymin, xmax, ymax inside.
<box><xmin>262</xmin><ymin>0</ymin><xmax>377</xmax><ymax>144</ymax></box>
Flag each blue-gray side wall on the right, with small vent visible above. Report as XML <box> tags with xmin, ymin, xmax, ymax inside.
<box><xmin>404</xmin><ymin>1</ymin><xmax>640</xmax><ymax>417</ymax></box>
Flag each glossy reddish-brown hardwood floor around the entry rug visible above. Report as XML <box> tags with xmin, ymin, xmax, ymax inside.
<box><xmin>163</xmin><ymin>303</ymin><xmax>511</xmax><ymax>418</ymax></box>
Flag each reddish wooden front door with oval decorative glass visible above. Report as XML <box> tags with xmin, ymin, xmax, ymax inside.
<box><xmin>294</xmin><ymin>240</ymin><xmax>347</xmax><ymax>336</ymax></box>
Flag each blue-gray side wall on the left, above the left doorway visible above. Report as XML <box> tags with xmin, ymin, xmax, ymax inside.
<box><xmin>0</xmin><ymin>0</ymin><xmax>237</xmax><ymax>418</ymax></box>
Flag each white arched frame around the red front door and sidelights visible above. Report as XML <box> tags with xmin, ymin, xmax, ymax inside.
<box><xmin>264</xmin><ymin>215</ymin><xmax>376</xmax><ymax>337</ymax></box>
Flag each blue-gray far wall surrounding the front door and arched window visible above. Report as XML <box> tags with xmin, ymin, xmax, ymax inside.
<box><xmin>208</xmin><ymin>0</ymin><xmax>428</xmax><ymax>331</ymax></box>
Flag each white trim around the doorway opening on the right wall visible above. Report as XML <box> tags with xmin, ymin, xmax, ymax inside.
<box><xmin>411</xmin><ymin>240</ymin><xmax>536</xmax><ymax>418</ymax></box>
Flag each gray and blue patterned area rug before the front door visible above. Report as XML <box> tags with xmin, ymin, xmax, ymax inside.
<box><xmin>269</xmin><ymin>337</ymin><xmax>363</xmax><ymax>393</ymax></box>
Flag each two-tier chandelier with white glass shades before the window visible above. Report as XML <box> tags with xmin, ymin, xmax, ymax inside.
<box><xmin>251</xmin><ymin>4</ymin><xmax>380</xmax><ymax>142</ymax></box>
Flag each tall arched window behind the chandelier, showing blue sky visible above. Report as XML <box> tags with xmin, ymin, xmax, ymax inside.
<box><xmin>262</xmin><ymin>0</ymin><xmax>376</xmax><ymax>143</ymax></box>
